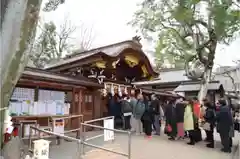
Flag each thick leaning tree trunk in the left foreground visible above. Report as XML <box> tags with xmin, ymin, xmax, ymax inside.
<box><xmin>0</xmin><ymin>0</ymin><xmax>42</xmax><ymax>154</ymax></box>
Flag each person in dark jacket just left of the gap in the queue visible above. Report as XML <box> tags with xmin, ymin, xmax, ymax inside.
<box><xmin>150</xmin><ymin>94</ymin><xmax>161</xmax><ymax>135</ymax></box>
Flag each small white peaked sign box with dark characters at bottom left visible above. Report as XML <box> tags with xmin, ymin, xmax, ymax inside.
<box><xmin>33</xmin><ymin>139</ymin><xmax>50</xmax><ymax>159</ymax></box>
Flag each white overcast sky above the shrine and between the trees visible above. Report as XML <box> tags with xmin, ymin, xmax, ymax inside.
<box><xmin>41</xmin><ymin>0</ymin><xmax>240</xmax><ymax>65</ymax></box>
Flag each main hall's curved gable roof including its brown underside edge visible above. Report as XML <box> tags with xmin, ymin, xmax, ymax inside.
<box><xmin>46</xmin><ymin>40</ymin><xmax>158</xmax><ymax>77</ymax></box>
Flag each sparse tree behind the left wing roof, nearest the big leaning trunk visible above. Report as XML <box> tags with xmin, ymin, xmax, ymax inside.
<box><xmin>30</xmin><ymin>18</ymin><xmax>76</xmax><ymax>68</ymax></box>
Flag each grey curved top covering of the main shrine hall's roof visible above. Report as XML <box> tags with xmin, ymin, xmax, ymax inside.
<box><xmin>45</xmin><ymin>40</ymin><xmax>158</xmax><ymax>76</ymax></box>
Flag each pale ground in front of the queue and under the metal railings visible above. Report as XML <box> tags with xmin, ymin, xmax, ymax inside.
<box><xmin>50</xmin><ymin>130</ymin><xmax>239</xmax><ymax>159</ymax></box>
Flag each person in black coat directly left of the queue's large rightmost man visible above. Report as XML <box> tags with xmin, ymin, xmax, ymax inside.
<box><xmin>204</xmin><ymin>101</ymin><xmax>216</xmax><ymax>148</ymax></box>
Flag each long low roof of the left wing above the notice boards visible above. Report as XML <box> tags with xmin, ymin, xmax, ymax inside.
<box><xmin>21</xmin><ymin>67</ymin><xmax>103</xmax><ymax>88</ymax></box>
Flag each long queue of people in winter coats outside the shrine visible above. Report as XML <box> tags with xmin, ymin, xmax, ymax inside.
<box><xmin>107</xmin><ymin>91</ymin><xmax>240</xmax><ymax>153</ymax></box>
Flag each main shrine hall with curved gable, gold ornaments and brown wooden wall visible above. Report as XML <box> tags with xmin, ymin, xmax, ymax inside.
<box><xmin>46</xmin><ymin>37</ymin><xmax>158</xmax><ymax>120</ymax></box>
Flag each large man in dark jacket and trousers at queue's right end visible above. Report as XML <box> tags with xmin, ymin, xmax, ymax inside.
<box><xmin>216</xmin><ymin>100</ymin><xmax>233</xmax><ymax>153</ymax></box>
